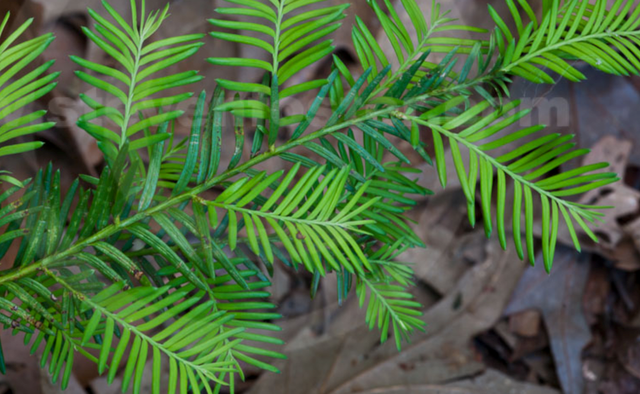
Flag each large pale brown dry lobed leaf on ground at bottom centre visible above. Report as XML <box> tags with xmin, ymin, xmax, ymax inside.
<box><xmin>250</xmin><ymin>235</ymin><xmax>525</xmax><ymax>394</ymax></box>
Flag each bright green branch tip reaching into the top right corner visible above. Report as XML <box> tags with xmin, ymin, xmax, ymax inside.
<box><xmin>496</xmin><ymin>0</ymin><xmax>640</xmax><ymax>83</ymax></box>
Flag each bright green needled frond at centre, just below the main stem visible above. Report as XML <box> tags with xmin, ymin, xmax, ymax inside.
<box><xmin>205</xmin><ymin>164</ymin><xmax>376</xmax><ymax>276</ymax></box>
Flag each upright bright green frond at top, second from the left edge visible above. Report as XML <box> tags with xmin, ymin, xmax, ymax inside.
<box><xmin>71</xmin><ymin>0</ymin><xmax>203</xmax><ymax>159</ymax></box>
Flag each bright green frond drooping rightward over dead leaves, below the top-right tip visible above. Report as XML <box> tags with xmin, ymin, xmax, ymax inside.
<box><xmin>409</xmin><ymin>99</ymin><xmax>619</xmax><ymax>270</ymax></box>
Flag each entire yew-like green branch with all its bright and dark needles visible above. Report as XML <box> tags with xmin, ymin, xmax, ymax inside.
<box><xmin>0</xmin><ymin>0</ymin><xmax>640</xmax><ymax>394</ymax></box>
